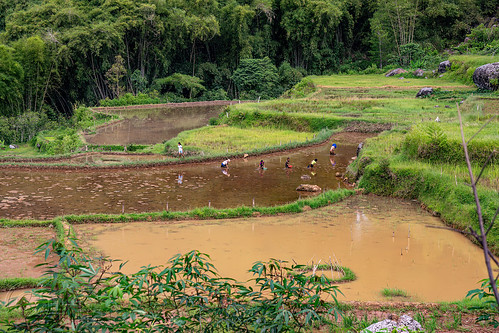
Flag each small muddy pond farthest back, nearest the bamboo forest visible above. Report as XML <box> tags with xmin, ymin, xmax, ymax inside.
<box><xmin>85</xmin><ymin>105</ymin><xmax>226</xmax><ymax>145</ymax></box>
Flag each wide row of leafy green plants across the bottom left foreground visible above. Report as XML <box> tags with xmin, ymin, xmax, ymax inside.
<box><xmin>0</xmin><ymin>239</ymin><xmax>339</xmax><ymax>332</ymax></box>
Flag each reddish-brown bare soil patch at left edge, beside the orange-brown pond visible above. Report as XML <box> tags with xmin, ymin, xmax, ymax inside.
<box><xmin>0</xmin><ymin>227</ymin><xmax>55</xmax><ymax>278</ymax></box>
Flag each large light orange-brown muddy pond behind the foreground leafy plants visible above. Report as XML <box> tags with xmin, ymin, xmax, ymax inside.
<box><xmin>76</xmin><ymin>196</ymin><xmax>486</xmax><ymax>302</ymax></box>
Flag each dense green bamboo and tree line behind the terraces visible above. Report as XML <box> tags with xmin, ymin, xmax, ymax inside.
<box><xmin>0</xmin><ymin>0</ymin><xmax>499</xmax><ymax>140</ymax></box>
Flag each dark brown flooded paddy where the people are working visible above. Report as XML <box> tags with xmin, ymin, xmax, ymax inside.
<box><xmin>0</xmin><ymin>142</ymin><xmax>357</xmax><ymax>219</ymax></box>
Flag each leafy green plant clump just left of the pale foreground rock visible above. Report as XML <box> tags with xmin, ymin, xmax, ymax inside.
<box><xmin>246</xmin><ymin>259</ymin><xmax>339</xmax><ymax>332</ymax></box>
